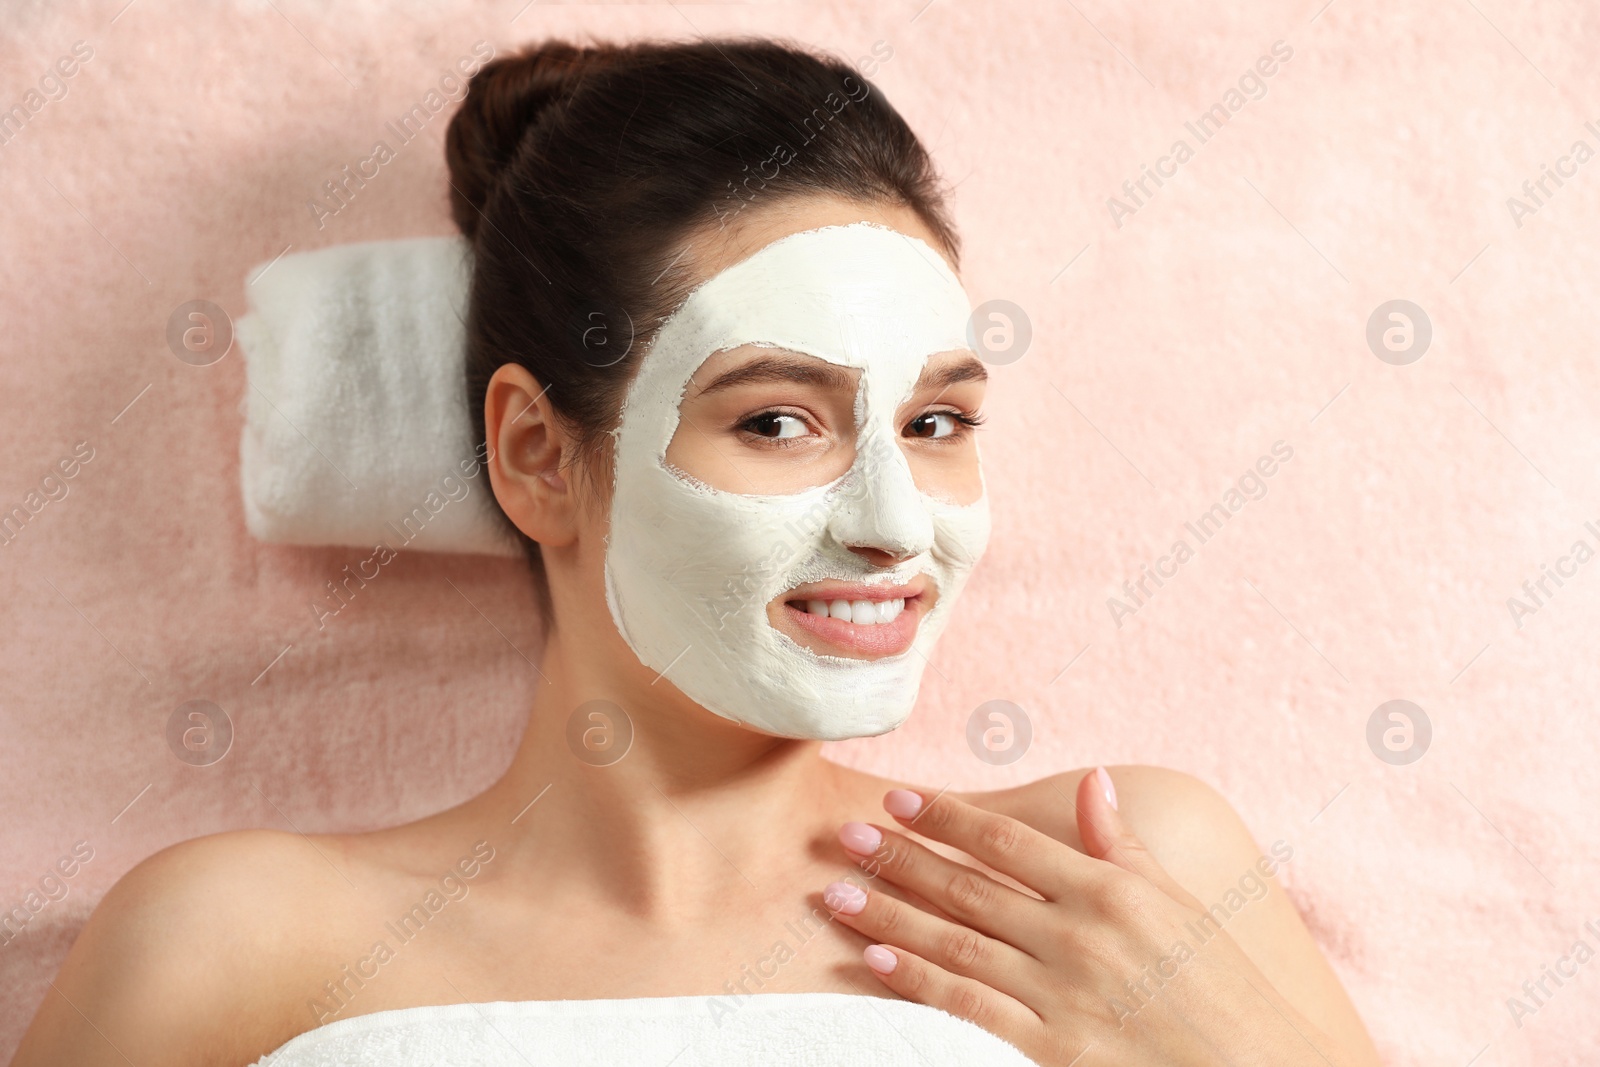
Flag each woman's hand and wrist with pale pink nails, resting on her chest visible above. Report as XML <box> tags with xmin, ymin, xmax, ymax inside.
<box><xmin>824</xmin><ymin>768</ymin><xmax>1342</xmax><ymax>1067</ymax></box>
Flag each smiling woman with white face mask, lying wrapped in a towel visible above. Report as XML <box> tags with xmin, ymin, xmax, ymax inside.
<box><xmin>13</xmin><ymin>40</ymin><xmax>1378</xmax><ymax>1067</ymax></box>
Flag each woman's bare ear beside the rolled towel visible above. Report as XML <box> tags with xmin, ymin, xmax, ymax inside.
<box><xmin>483</xmin><ymin>363</ymin><xmax>578</xmax><ymax>549</ymax></box>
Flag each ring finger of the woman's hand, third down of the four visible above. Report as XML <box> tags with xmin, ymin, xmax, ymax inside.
<box><xmin>822</xmin><ymin>881</ymin><xmax>1040</xmax><ymax>998</ymax></box>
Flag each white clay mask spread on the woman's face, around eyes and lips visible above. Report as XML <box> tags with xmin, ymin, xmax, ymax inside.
<box><xmin>605</xmin><ymin>222</ymin><xmax>989</xmax><ymax>741</ymax></box>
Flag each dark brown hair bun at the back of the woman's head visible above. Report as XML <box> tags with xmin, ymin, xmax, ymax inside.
<box><xmin>445</xmin><ymin>42</ymin><xmax>621</xmax><ymax>240</ymax></box>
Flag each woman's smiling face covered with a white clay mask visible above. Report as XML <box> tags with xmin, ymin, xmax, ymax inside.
<box><xmin>490</xmin><ymin>198</ymin><xmax>989</xmax><ymax>739</ymax></box>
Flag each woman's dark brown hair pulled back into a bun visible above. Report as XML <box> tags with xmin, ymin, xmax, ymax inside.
<box><xmin>445</xmin><ymin>38</ymin><xmax>960</xmax><ymax>624</ymax></box>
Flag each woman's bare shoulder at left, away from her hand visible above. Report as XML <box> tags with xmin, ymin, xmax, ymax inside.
<box><xmin>11</xmin><ymin>830</ymin><xmax>353</xmax><ymax>1067</ymax></box>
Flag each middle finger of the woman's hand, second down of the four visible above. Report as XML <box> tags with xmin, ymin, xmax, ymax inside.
<box><xmin>838</xmin><ymin>822</ymin><xmax>1045</xmax><ymax>955</ymax></box>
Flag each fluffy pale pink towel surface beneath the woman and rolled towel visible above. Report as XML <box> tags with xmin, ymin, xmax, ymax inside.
<box><xmin>0</xmin><ymin>0</ymin><xmax>1600</xmax><ymax>1067</ymax></box>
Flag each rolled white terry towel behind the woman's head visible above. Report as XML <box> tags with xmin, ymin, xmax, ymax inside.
<box><xmin>235</xmin><ymin>237</ymin><xmax>520</xmax><ymax>557</ymax></box>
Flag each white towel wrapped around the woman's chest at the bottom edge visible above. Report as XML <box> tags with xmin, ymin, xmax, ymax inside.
<box><xmin>251</xmin><ymin>993</ymin><xmax>1038</xmax><ymax>1067</ymax></box>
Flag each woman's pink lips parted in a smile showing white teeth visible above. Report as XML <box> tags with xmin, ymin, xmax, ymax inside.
<box><xmin>781</xmin><ymin>584</ymin><xmax>926</xmax><ymax>659</ymax></box>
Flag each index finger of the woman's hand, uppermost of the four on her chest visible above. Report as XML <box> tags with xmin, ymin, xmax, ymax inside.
<box><xmin>883</xmin><ymin>789</ymin><xmax>1090</xmax><ymax>901</ymax></box>
